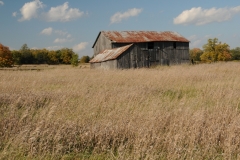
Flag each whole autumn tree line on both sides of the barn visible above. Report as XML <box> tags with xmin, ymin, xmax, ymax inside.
<box><xmin>0</xmin><ymin>38</ymin><xmax>240</xmax><ymax>67</ymax></box>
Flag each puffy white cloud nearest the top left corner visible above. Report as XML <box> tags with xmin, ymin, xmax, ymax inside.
<box><xmin>19</xmin><ymin>0</ymin><xmax>43</xmax><ymax>22</ymax></box>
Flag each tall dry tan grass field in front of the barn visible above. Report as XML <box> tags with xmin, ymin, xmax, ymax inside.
<box><xmin>0</xmin><ymin>62</ymin><xmax>240</xmax><ymax>160</ymax></box>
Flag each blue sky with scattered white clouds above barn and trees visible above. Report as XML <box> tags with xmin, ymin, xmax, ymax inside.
<box><xmin>0</xmin><ymin>0</ymin><xmax>240</xmax><ymax>56</ymax></box>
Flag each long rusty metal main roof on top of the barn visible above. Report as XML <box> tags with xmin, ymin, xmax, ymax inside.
<box><xmin>101</xmin><ymin>31</ymin><xmax>189</xmax><ymax>43</ymax></box>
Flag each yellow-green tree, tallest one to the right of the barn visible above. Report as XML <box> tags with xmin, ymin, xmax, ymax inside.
<box><xmin>200</xmin><ymin>38</ymin><xmax>231</xmax><ymax>62</ymax></box>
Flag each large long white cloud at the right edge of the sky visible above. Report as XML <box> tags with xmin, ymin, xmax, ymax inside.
<box><xmin>173</xmin><ymin>6</ymin><xmax>240</xmax><ymax>25</ymax></box>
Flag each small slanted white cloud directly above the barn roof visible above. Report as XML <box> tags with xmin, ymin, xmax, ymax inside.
<box><xmin>110</xmin><ymin>8</ymin><xmax>142</xmax><ymax>24</ymax></box>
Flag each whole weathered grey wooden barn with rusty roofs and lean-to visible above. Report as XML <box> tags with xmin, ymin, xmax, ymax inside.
<box><xmin>90</xmin><ymin>31</ymin><xmax>189</xmax><ymax>69</ymax></box>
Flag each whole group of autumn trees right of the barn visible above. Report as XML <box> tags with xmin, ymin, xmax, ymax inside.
<box><xmin>190</xmin><ymin>38</ymin><xmax>240</xmax><ymax>63</ymax></box>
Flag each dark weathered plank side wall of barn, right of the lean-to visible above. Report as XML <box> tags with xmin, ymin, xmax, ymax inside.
<box><xmin>131</xmin><ymin>42</ymin><xmax>189</xmax><ymax>68</ymax></box>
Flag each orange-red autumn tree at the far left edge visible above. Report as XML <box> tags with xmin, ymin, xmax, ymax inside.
<box><xmin>0</xmin><ymin>43</ymin><xmax>13</xmax><ymax>67</ymax></box>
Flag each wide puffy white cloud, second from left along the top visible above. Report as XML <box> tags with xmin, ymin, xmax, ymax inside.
<box><xmin>42</xmin><ymin>2</ymin><xmax>84</xmax><ymax>22</ymax></box>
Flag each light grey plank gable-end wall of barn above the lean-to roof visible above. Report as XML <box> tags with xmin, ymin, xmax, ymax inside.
<box><xmin>93</xmin><ymin>33</ymin><xmax>112</xmax><ymax>56</ymax></box>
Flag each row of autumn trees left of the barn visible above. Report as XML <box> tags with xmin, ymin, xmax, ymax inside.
<box><xmin>0</xmin><ymin>44</ymin><xmax>90</xmax><ymax>67</ymax></box>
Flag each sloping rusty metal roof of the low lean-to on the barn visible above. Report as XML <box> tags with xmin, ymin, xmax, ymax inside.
<box><xmin>89</xmin><ymin>44</ymin><xmax>133</xmax><ymax>63</ymax></box>
